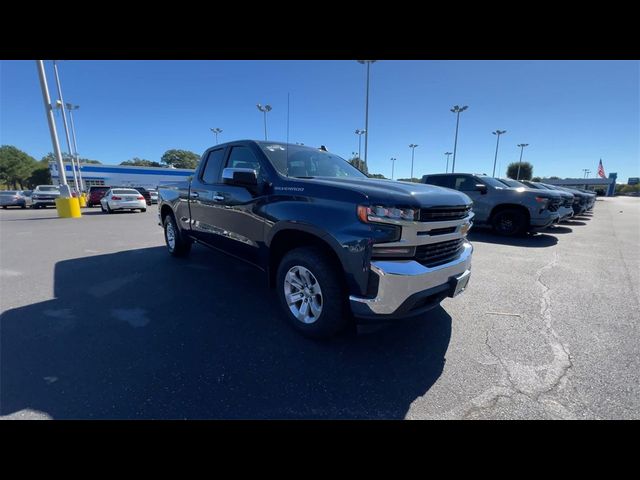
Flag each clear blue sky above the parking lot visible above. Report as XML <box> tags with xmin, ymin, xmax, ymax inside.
<box><xmin>0</xmin><ymin>60</ymin><xmax>640</xmax><ymax>183</ymax></box>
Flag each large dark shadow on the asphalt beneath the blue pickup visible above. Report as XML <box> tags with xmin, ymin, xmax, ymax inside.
<box><xmin>0</xmin><ymin>246</ymin><xmax>451</xmax><ymax>419</ymax></box>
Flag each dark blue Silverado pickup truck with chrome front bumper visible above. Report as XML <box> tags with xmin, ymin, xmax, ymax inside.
<box><xmin>158</xmin><ymin>140</ymin><xmax>474</xmax><ymax>338</ymax></box>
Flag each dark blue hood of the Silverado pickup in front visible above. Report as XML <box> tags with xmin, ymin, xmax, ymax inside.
<box><xmin>300</xmin><ymin>177</ymin><xmax>472</xmax><ymax>208</ymax></box>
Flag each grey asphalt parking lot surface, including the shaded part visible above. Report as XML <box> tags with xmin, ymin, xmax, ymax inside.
<box><xmin>0</xmin><ymin>197</ymin><xmax>640</xmax><ymax>419</ymax></box>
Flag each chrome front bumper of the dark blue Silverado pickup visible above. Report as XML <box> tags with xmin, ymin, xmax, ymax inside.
<box><xmin>349</xmin><ymin>242</ymin><xmax>473</xmax><ymax>318</ymax></box>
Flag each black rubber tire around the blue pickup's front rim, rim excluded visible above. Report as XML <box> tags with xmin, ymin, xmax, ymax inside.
<box><xmin>276</xmin><ymin>247</ymin><xmax>352</xmax><ymax>339</ymax></box>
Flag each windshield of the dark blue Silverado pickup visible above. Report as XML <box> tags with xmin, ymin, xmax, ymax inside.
<box><xmin>259</xmin><ymin>142</ymin><xmax>367</xmax><ymax>178</ymax></box>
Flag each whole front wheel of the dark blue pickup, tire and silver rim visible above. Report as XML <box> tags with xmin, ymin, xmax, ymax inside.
<box><xmin>276</xmin><ymin>247</ymin><xmax>351</xmax><ymax>339</ymax></box>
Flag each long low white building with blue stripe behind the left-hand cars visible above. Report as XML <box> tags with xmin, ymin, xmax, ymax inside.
<box><xmin>49</xmin><ymin>162</ymin><xmax>193</xmax><ymax>189</ymax></box>
